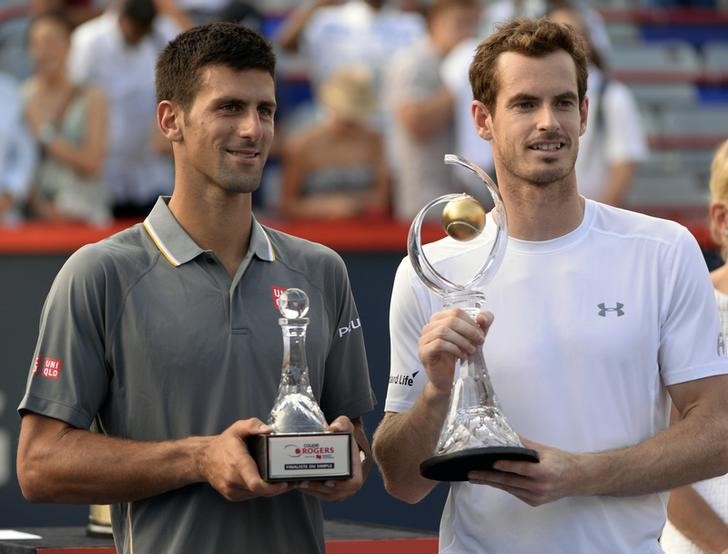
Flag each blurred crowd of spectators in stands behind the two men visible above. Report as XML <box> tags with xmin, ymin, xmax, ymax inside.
<box><xmin>0</xmin><ymin>0</ymin><xmax>728</xmax><ymax>225</ymax></box>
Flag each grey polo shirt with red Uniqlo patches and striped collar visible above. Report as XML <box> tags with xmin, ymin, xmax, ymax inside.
<box><xmin>18</xmin><ymin>199</ymin><xmax>374</xmax><ymax>554</ymax></box>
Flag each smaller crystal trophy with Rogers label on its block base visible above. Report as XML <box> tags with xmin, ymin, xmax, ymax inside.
<box><xmin>252</xmin><ymin>288</ymin><xmax>351</xmax><ymax>482</ymax></box>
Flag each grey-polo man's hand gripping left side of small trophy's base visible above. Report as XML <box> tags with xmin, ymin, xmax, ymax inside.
<box><xmin>198</xmin><ymin>418</ymin><xmax>290</xmax><ymax>502</ymax></box>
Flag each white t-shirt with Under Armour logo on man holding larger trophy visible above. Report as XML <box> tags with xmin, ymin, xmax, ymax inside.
<box><xmin>385</xmin><ymin>200</ymin><xmax>728</xmax><ymax>554</ymax></box>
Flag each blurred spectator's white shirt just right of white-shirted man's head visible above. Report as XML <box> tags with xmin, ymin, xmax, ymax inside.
<box><xmin>576</xmin><ymin>66</ymin><xmax>648</xmax><ymax>200</ymax></box>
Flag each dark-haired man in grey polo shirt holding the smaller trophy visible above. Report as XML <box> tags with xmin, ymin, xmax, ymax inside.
<box><xmin>18</xmin><ymin>23</ymin><xmax>374</xmax><ymax>554</ymax></box>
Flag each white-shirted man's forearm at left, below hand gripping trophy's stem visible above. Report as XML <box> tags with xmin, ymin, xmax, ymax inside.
<box><xmin>373</xmin><ymin>383</ymin><xmax>449</xmax><ymax>503</ymax></box>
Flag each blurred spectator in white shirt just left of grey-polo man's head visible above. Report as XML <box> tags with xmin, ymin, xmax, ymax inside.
<box><xmin>68</xmin><ymin>0</ymin><xmax>179</xmax><ymax>217</ymax></box>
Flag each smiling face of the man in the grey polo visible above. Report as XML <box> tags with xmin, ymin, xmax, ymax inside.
<box><xmin>175</xmin><ymin>65</ymin><xmax>276</xmax><ymax>193</ymax></box>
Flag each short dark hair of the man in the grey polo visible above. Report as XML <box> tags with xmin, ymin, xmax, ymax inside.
<box><xmin>155</xmin><ymin>22</ymin><xmax>276</xmax><ymax>111</ymax></box>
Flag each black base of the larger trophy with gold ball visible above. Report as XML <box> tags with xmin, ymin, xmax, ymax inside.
<box><xmin>420</xmin><ymin>446</ymin><xmax>539</xmax><ymax>481</ymax></box>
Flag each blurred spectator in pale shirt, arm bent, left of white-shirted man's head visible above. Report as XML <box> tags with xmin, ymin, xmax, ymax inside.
<box><xmin>382</xmin><ymin>0</ymin><xmax>479</xmax><ymax>219</ymax></box>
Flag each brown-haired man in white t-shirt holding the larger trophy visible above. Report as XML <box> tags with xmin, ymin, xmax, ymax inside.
<box><xmin>374</xmin><ymin>19</ymin><xmax>728</xmax><ymax>554</ymax></box>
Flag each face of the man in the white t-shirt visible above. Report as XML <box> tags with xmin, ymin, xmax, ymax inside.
<box><xmin>479</xmin><ymin>50</ymin><xmax>587</xmax><ymax>185</ymax></box>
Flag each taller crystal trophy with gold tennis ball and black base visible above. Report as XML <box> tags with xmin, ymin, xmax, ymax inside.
<box><xmin>407</xmin><ymin>154</ymin><xmax>538</xmax><ymax>481</ymax></box>
